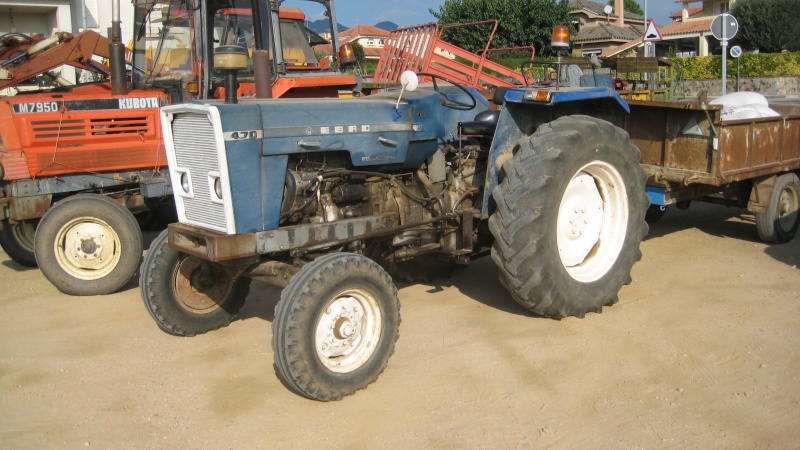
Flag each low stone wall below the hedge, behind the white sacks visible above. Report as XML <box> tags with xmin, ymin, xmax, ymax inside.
<box><xmin>675</xmin><ymin>74</ymin><xmax>800</xmax><ymax>98</ymax></box>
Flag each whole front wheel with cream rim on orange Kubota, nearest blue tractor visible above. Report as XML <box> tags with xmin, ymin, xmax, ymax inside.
<box><xmin>34</xmin><ymin>194</ymin><xmax>142</xmax><ymax>295</ymax></box>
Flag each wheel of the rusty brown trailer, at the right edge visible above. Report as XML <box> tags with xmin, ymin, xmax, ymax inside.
<box><xmin>756</xmin><ymin>172</ymin><xmax>800</xmax><ymax>244</ymax></box>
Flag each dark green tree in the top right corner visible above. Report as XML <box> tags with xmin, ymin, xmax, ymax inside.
<box><xmin>731</xmin><ymin>0</ymin><xmax>800</xmax><ymax>53</ymax></box>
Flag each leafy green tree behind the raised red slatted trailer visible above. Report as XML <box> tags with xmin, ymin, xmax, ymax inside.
<box><xmin>428</xmin><ymin>0</ymin><xmax>574</xmax><ymax>54</ymax></box>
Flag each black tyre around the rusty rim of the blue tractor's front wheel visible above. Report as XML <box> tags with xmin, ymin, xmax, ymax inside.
<box><xmin>139</xmin><ymin>230</ymin><xmax>251</xmax><ymax>336</ymax></box>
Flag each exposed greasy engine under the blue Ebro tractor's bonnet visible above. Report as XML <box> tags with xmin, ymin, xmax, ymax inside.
<box><xmin>280</xmin><ymin>145</ymin><xmax>488</xmax><ymax>260</ymax></box>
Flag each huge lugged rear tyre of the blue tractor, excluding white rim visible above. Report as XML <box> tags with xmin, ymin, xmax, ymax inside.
<box><xmin>489</xmin><ymin>116</ymin><xmax>649</xmax><ymax>319</ymax></box>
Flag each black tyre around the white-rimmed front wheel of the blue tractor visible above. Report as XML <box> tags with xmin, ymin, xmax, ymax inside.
<box><xmin>272</xmin><ymin>253</ymin><xmax>401</xmax><ymax>401</ymax></box>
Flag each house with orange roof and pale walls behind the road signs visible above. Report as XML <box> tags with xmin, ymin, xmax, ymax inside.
<box><xmin>661</xmin><ymin>0</ymin><xmax>735</xmax><ymax>56</ymax></box>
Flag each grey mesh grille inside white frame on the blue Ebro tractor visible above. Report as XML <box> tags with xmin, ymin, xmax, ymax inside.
<box><xmin>172</xmin><ymin>113</ymin><xmax>232</xmax><ymax>232</ymax></box>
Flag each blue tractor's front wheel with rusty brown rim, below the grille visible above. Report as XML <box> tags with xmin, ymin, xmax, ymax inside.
<box><xmin>139</xmin><ymin>230</ymin><xmax>251</xmax><ymax>336</ymax></box>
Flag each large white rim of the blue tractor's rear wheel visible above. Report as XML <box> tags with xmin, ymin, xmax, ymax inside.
<box><xmin>556</xmin><ymin>161</ymin><xmax>628</xmax><ymax>283</ymax></box>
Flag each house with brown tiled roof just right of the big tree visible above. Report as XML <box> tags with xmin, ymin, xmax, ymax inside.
<box><xmin>570</xmin><ymin>0</ymin><xmax>644</xmax><ymax>55</ymax></box>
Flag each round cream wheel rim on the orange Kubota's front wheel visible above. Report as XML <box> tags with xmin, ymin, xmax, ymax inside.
<box><xmin>54</xmin><ymin>217</ymin><xmax>122</xmax><ymax>280</ymax></box>
